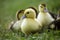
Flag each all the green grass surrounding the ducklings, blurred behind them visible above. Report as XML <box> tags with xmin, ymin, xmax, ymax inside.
<box><xmin>0</xmin><ymin>0</ymin><xmax>60</xmax><ymax>40</ymax></box>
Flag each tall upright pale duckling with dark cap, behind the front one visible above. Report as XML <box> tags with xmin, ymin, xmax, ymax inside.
<box><xmin>37</xmin><ymin>4</ymin><xmax>54</xmax><ymax>27</ymax></box>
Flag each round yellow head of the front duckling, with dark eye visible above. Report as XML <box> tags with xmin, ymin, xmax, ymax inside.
<box><xmin>24</xmin><ymin>8</ymin><xmax>36</xmax><ymax>18</ymax></box>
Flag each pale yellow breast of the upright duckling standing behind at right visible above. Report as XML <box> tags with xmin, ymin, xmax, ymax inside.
<box><xmin>37</xmin><ymin>13</ymin><xmax>54</xmax><ymax>25</ymax></box>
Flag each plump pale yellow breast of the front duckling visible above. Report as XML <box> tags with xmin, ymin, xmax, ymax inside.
<box><xmin>21</xmin><ymin>19</ymin><xmax>39</xmax><ymax>33</ymax></box>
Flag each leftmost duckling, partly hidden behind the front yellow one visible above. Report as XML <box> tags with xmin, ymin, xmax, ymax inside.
<box><xmin>10</xmin><ymin>10</ymin><xmax>24</xmax><ymax>31</ymax></box>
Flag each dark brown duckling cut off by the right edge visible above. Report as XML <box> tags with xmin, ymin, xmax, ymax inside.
<box><xmin>48</xmin><ymin>10</ymin><xmax>60</xmax><ymax>30</ymax></box>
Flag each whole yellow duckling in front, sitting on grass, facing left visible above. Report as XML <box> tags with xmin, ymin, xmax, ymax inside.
<box><xmin>21</xmin><ymin>8</ymin><xmax>41</xmax><ymax>35</ymax></box>
